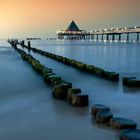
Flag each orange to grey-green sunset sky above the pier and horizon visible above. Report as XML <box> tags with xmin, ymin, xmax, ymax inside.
<box><xmin>0</xmin><ymin>0</ymin><xmax>140</xmax><ymax>38</ymax></box>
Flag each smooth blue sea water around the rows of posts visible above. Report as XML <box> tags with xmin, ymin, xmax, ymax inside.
<box><xmin>0</xmin><ymin>39</ymin><xmax>140</xmax><ymax>140</ymax></box>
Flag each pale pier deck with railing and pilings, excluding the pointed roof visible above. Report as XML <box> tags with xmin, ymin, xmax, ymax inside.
<box><xmin>57</xmin><ymin>27</ymin><xmax>140</xmax><ymax>41</ymax></box>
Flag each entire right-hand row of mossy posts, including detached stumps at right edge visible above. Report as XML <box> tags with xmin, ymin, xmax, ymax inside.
<box><xmin>19</xmin><ymin>41</ymin><xmax>140</xmax><ymax>88</ymax></box>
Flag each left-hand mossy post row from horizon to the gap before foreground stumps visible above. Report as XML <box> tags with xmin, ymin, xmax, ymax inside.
<box><xmin>8</xmin><ymin>41</ymin><xmax>89</xmax><ymax>107</ymax></box>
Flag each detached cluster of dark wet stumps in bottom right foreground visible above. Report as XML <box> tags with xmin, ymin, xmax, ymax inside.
<box><xmin>91</xmin><ymin>104</ymin><xmax>140</xmax><ymax>140</ymax></box>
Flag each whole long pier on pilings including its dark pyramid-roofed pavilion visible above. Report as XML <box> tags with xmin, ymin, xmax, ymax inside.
<box><xmin>57</xmin><ymin>21</ymin><xmax>140</xmax><ymax>42</ymax></box>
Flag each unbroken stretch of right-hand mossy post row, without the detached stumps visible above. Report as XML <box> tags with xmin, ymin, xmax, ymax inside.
<box><xmin>19</xmin><ymin>41</ymin><xmax>119</xmax><ymax>82</ymax></box>
